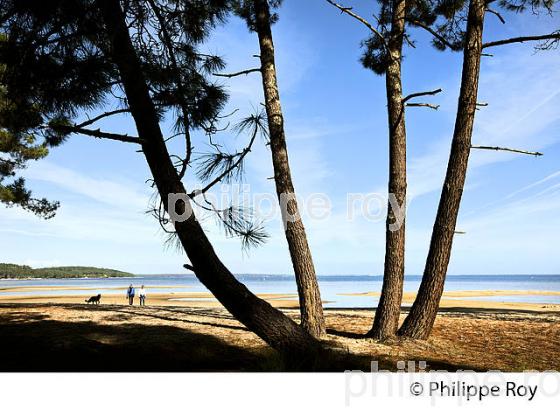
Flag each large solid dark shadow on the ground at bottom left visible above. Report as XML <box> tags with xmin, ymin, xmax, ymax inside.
<box><xmin>0</xmin><ymin>316</ymin><xmax>270</xmax><ymax>371</ymax></box>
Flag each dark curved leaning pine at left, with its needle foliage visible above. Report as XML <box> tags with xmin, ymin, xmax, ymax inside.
<box><xmin>0</xmin><ymin>0</ymin><xmax>317</xmax><ymax>355</ymax></box>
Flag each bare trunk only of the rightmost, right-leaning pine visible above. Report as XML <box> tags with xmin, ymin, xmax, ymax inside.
<box><xmin>399</xmin><ymin>0</ymin><xmax>486</xmax><ymax>339</ymax></box>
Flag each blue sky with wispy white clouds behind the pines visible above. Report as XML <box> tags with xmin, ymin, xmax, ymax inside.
<box><xmin>0</xmin><ymin>0</ymin><xmax>560</xmax><ymax>275</ymax></box>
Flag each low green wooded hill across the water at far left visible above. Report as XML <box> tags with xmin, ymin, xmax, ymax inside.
<box><xmin>0</xmin><ymin>263</ymin><xmax>134</xmax><ymax>279</ymax></box>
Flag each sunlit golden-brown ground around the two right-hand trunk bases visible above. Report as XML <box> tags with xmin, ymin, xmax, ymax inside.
<box><xmin>320</xmin><ymin>308</ymin><xmax>560</xmax><ymax>372</ymax></box>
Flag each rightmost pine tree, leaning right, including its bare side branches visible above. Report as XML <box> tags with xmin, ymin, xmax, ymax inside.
<box><xmin>399</xmin><ymin>0</ymin><xmax>560</xmax><ymax>339</ymax></box>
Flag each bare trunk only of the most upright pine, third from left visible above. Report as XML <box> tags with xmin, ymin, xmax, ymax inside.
<box><xmin>368</xmin><ymin>0</ymin><xmax>406</xmax><ymax>339</ymax></box>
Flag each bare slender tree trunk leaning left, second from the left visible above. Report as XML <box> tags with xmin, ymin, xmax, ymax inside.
<box><xmin>254</xmin><ymin>0</ymin><xmax>326</xmax><ymax>338</ymax></box>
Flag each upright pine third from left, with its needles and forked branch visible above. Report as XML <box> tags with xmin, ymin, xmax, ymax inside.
<box><xmin>327</xmin><ymin>0</ymin><xmax>450</xmax><ymax>339</ymax></box>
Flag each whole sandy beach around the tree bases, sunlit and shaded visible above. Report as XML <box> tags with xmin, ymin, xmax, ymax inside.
<box><xmin>0</xmin><ymin>286</ymin><xmax>560</xmax><ymax>371</ymax></box>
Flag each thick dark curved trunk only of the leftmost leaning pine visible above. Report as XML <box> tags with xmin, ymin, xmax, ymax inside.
<box><xmin>98</xmin><ymin>0</ymin><xmax>317</xmax><ymax>355</ymax></box>
